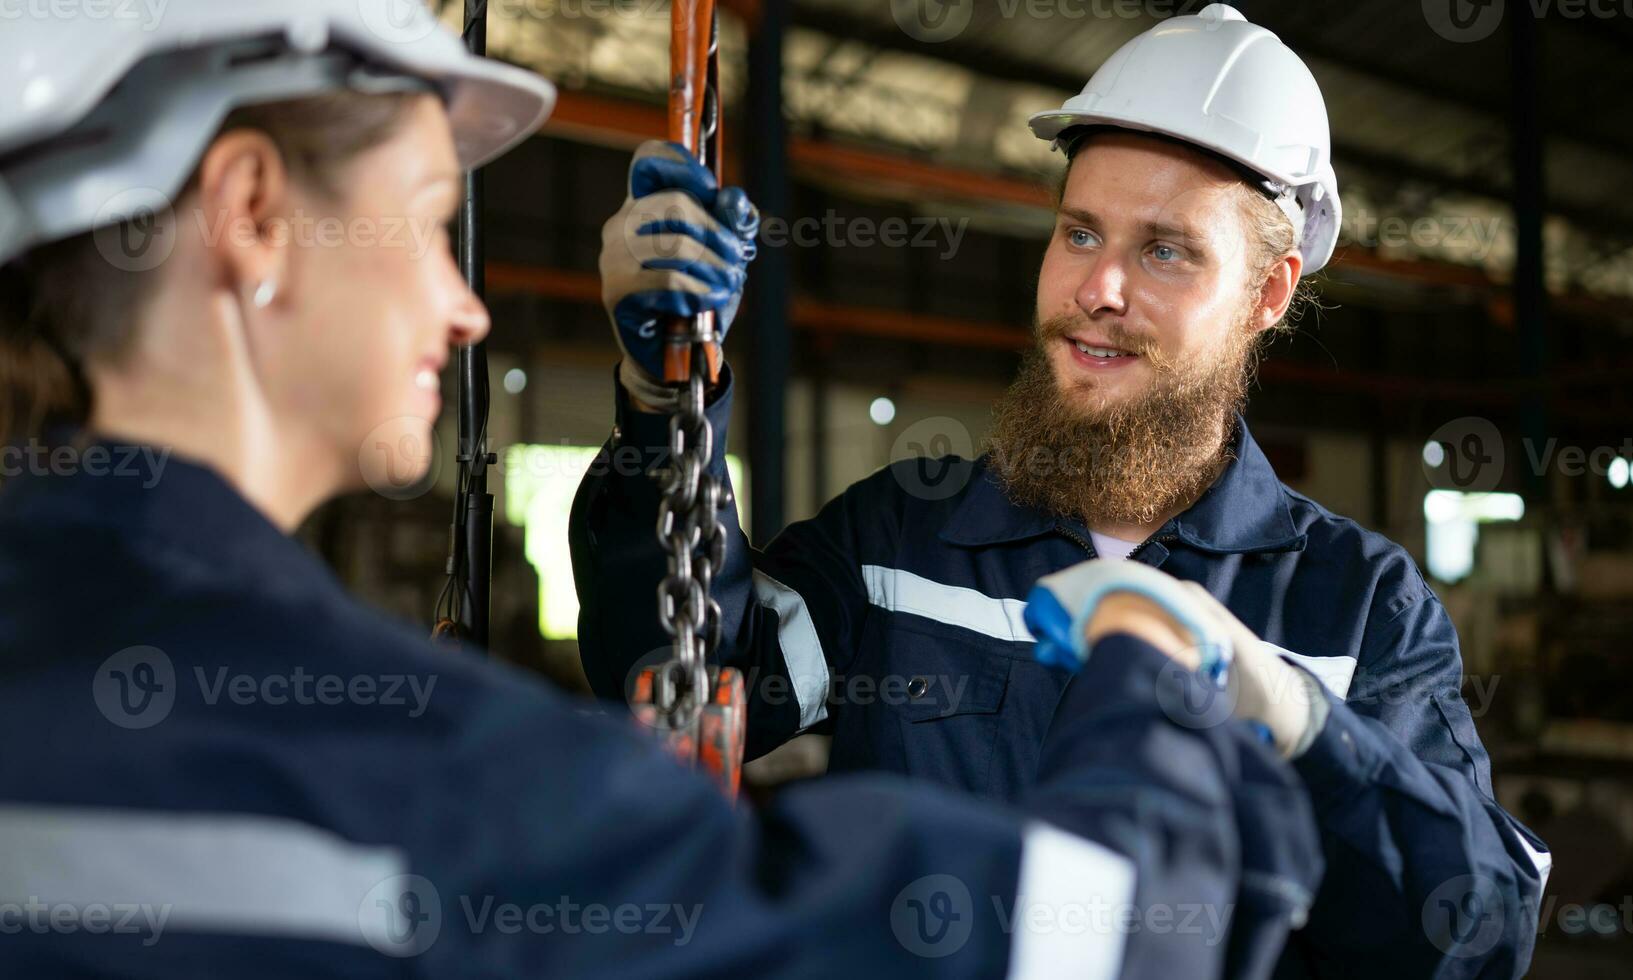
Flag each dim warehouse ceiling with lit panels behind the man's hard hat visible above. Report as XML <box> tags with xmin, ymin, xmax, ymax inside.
<box><xmin>444</xmin><ymin>0</ymin><xmax>1633</xmax><ymax>297</ymax></box>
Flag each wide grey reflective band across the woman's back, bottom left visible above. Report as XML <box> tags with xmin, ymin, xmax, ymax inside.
<box><xmin>0</xmin><ymin>805</ymin><xmax>408</xmax><ymax>949</ymax></box>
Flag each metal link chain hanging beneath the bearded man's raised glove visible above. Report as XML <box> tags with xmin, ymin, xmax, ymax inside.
<box><xmin>653</xmin><ymin>15</ymin><xmax>732</xmax><ymax>728</ymax></box>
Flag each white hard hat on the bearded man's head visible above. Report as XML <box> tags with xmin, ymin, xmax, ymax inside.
<box><xmin>1032</xmin><ymin>3</ymin><xmax>1342</xmax><ymax>274</ymax></box>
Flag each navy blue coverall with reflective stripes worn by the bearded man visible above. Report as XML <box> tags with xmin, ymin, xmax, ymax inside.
<box><xmin>572</xmin><ymin>370</ymin><xmax>1550</xmax><ymax>977</ymax></box>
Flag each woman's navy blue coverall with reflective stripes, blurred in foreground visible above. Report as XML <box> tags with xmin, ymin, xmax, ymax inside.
<box><xmin>0</xmin><ymin>443</ymin><xmax>1321</xmax><ymax>980</ymax></box>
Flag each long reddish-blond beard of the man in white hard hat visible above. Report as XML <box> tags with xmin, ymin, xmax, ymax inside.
<box><xmin>986</xmin><ymin>315</ymin><xmax>1261</xmax><ymax>528</ymax></box>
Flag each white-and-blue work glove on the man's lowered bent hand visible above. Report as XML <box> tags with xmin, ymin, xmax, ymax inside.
<box><xmin>1024</xmin><ymin>559</ymin><xmax>1328</xmax><ymax>758</ymax></box>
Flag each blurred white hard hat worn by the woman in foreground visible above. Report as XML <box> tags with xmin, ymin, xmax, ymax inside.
<box><xmin>0</xmin><ymin>0</ymin><xmax>555</xmax><ymax>265</ymax></box>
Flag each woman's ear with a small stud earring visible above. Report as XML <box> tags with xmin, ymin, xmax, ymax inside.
<box><xmin>198</xmin><ymin>129</ymin><xmax>291</xmax><ymax>296</ymax></box>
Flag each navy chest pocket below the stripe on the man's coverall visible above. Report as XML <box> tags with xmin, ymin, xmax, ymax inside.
<box><xmin>880</xmin><ymin>627</ymin><xmax>1011</xmax><ymax>797</ymax></box>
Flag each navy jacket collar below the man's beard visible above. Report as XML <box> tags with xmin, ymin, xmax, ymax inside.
<box><xmin>941</xmin><ymin>415</ymin><xmax>1305</xmax><ymax>554</ymax></box>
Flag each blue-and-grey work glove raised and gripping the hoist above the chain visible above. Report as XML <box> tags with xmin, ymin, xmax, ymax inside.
<box><xmin>601</xmin><ymin>140</ymin><xmax>759</xmax><ymax>410</ymax></box>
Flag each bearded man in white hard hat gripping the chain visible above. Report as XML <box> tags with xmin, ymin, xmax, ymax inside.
<box><xmin>572</xmin><ymin>5</ymin><xmax>1548</xmax><ymax>977</ymax></box>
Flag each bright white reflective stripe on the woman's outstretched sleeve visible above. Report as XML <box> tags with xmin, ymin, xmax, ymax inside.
<box><xmin>1009</xmin><ymin>823</ymin><xmax>1137</xmax><ymax>980</ymax></box>
